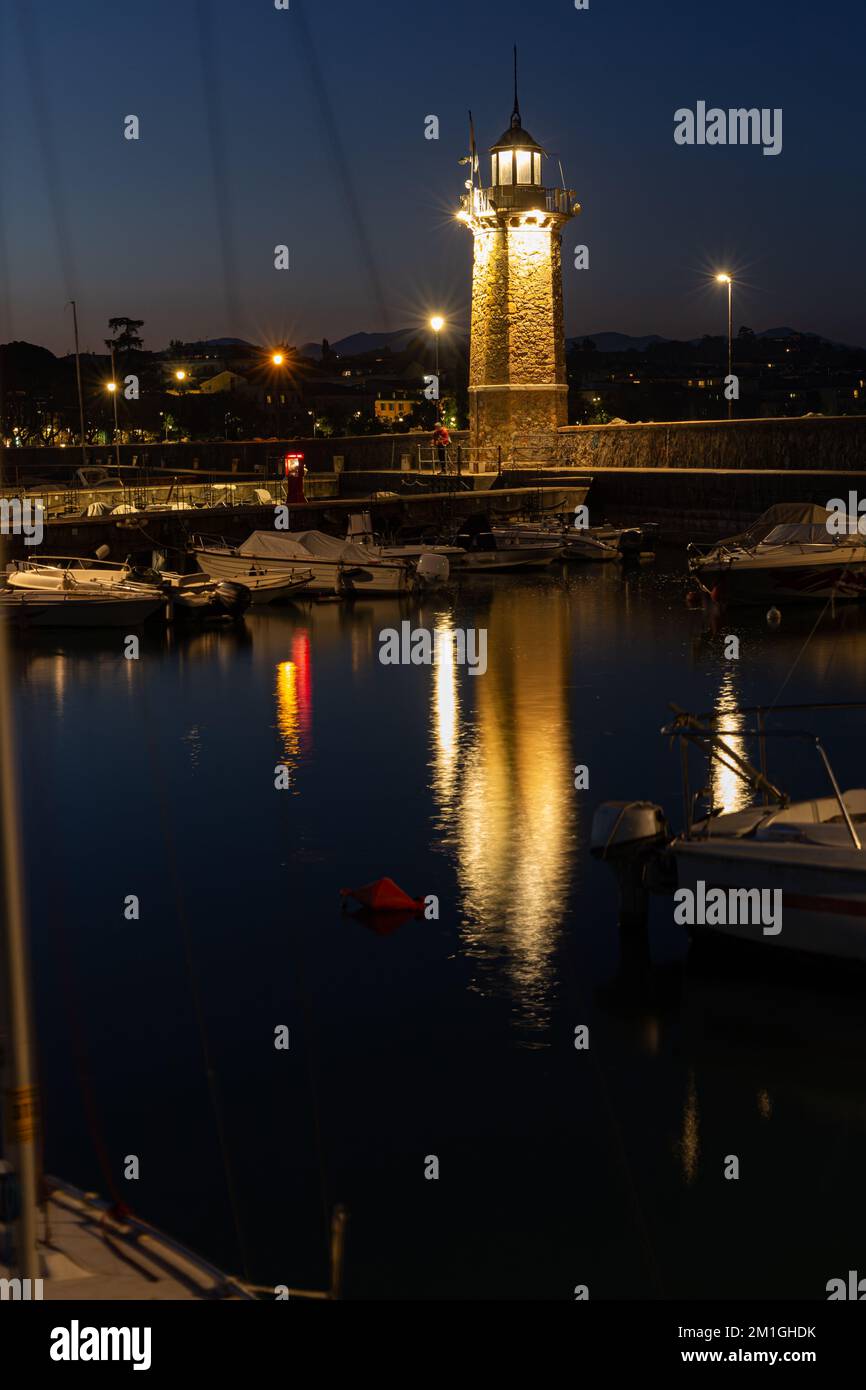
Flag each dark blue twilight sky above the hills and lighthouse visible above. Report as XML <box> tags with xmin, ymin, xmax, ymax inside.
<box><xmin>0</xmin><ymin>0</ymin><xmax>866</xmax><ymax>352</ymax></box>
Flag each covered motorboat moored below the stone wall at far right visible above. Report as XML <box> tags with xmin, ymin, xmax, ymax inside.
<box><xmin>689</xmin><ymin>502</ymin><xmax>866</xmax><ymax>603</ymax></box>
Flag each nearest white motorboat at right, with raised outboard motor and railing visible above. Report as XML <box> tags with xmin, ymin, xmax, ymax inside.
<box><xmin>592</xmin><ymin>706</ymin><xmax>866</xmax><ymax>962</ymax></box>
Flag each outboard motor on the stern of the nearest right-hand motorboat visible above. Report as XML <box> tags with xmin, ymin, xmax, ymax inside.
<box><xmin>589</xmin><ymin>801</ymin><xmax>670</xmax><ymax>927</ymax></box>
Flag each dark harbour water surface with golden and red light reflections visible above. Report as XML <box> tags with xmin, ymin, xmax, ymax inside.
<box><xmin>17</xmin><ymin>563</ymin><xmax>866</xmax><ymax>1298</ymax></box>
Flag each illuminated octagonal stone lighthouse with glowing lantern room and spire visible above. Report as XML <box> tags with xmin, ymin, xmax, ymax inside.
<box><xmin>457</xmin><ymin>56</ymin><xmax>580</xmax><ymax>461</ymax></box>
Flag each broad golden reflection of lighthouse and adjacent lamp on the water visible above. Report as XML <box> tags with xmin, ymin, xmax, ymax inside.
<box><xmin>431</xmin><ymin>588</ymin><xmax>575</xmax><ymax>1031</ymax></box>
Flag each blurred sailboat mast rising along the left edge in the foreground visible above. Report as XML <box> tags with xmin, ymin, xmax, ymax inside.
<box><xmin>0</xmin><ymin>539</ymin><xmax>39</xmax><ymax>1279</ymax></box>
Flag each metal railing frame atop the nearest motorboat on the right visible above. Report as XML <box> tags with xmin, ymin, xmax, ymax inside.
<box><xmin>662</xmin><ymin>701</ymin><xmax>866</xmax><ymax>849</ymax></box>
